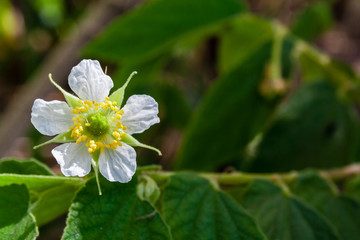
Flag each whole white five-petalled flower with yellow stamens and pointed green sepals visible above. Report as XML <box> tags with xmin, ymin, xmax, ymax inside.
<box><xmin>31</xmin><ymin>60</ymin><xmax>160</xmax><ymax>186</ymax></box>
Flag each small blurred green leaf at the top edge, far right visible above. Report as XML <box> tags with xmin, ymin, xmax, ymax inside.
<box><xmin>291</xmin><ymin>1</ymin><xmax>334</xmax><ymax>41</ymax></box>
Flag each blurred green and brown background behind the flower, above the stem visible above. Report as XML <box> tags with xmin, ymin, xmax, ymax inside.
<box><xmin>0</xmin><ymin>0</ymin><xmax>360</xmax><ymax>239</ymax></box>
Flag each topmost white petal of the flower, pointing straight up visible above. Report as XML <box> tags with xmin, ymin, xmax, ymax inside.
<box><xmin>68</xmin><ymin>60</ymin><xmax>114</xmax><ymax>102</ymax></box>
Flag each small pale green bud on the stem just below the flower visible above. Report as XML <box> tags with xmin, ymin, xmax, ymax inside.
<box><xmin>136</xmin><ymin>175</ymin><xmax>160</xmax><ymax>205</ymax></box>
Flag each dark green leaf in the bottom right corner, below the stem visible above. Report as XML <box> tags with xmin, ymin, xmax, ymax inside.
<box><xmin>292</xmin><ymin>171</ymin><xmax>360</xmax><ymax>240</ymax></box>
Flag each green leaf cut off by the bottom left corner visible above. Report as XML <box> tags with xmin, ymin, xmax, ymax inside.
<box><xmin>0</xmin><ymin>184</ymin><xmax>38</xmax><ymax>240</ymax></box>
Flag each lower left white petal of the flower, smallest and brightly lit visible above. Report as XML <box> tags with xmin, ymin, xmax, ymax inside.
<box><xmin>51</xmin><ymin>143</ymin><xmax>91</xmax><ymax>177</ymax></box>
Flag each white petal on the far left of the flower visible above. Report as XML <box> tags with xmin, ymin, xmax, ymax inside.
<box><xmin>31</xmin><ymin>99</ymin><xmax>74</xmax><ymax>136</ymax></box>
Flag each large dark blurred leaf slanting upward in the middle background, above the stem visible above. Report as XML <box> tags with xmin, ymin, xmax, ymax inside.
<box><xmin>175</xmin><ymin>42</ymin><xmax>275</xmax><ymax>171</ymax></box>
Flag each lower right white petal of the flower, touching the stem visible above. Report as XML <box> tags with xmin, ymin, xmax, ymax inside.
<box><xmin>99</xmin><ymin>143</ymin><xmax>136</xmax><ymax>183</ymax></box>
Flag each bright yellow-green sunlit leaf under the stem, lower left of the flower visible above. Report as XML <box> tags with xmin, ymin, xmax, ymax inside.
<box><xmin>0</xmin><ymin>174</ymin><xmax>84</xmax><ymax>226</ymax></box>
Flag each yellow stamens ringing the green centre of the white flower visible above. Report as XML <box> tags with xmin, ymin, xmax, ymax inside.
<box><xmin>70</xmin><ymin>97</ymin><xmax>126</xmax><ymax>154</ymax></box>
